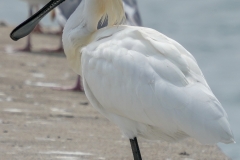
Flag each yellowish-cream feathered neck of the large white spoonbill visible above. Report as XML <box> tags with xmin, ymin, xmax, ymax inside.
<box><xmin>63</xmin><ymin>0</ymin><xmax>125</xmax><ymax>74</ymax></box>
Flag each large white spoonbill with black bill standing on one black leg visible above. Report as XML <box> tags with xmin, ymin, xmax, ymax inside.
<box><xmin>11</xmin><ymin>0</ymin><xmax>234</xmax><ymax>160</ymax></box>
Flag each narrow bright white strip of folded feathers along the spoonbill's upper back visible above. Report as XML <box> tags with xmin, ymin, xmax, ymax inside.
<box><xmin>140</xmin><ymin>28</ymin><xmax>211</xmax><ymax>90</ymax></box>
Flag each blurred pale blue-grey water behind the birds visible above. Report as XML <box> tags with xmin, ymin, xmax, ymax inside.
<box><xmin>0</xmin><ymin>0</ymin><xmax>240</xmax><ymax>160</ymax></box>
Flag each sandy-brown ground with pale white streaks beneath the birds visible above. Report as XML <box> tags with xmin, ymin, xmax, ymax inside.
<box><xmin>0</xmin><ymin>26</ymin><xmax>228</xmax><ymax>160</ymax></box>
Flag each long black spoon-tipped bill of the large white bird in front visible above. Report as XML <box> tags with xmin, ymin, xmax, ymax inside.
<box><xmin>10</xmin><ymin>0</ymin><xmax>65</xmax><ymax>41</ymax></box>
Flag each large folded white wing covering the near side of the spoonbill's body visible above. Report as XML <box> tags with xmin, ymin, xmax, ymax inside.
<box><xmin>82</xmin><ymin>26</ymin><xmax>231</xmax><ymax>143</ymax></box>
